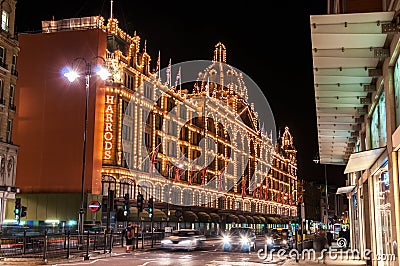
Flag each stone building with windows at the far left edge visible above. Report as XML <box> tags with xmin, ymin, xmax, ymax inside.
<box><xmin>0</xmin><ymin>0</ymin><xmax>19</xmax><ymax>224</ymax></box>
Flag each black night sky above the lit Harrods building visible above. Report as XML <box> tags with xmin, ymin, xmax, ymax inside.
<box><xmin>16</xmin><ymin>0</ymin><xmax>345</xmax><ymax>185</ymax></box>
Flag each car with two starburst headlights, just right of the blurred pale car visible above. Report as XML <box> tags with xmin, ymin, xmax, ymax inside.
<box><xmin>222</xmin><ymin>227</ymin><xmax>256</xmax><ymax>252</ymax></box>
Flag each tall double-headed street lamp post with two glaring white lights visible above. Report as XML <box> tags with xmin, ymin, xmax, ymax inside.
<box><xmin>64</xmin><ymin>56</ymin><xmax>110</xmax><ymax>235</ymax></box>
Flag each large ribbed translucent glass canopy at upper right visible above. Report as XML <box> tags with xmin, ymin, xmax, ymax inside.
<box><xmin>309</xmin><ymin>11</ymin><xmax>396</xmax><ymax>165</ymax></box>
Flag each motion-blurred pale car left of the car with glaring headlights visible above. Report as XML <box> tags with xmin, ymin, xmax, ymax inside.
<box><xmin>161</xmin><ymin>229</ymin><xmax>206</xmax><ymax>251</ymax></box>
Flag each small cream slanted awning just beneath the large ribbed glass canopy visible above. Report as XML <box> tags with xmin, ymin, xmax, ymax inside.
<box><xmin>344</xmin><ymin>147</ymin><xmax>386</xmax><ymax>174</ymax></box>
